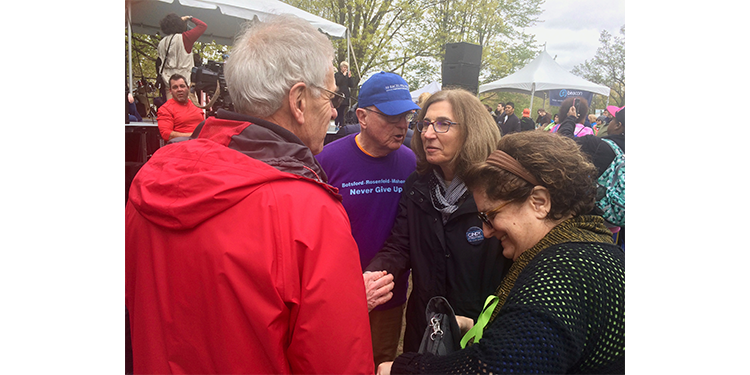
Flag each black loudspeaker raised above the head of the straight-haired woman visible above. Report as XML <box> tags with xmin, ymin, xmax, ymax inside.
<box><xmin>442</xmin><ymin>42</ymin><xmax>482</xmax><ymax>94</ymax></box>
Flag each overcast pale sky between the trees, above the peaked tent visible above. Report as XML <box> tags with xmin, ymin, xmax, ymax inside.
<box><xmin>526</xmin><ymin>0</ymin><xmax>625</xmax><ymax>71</ymax></box>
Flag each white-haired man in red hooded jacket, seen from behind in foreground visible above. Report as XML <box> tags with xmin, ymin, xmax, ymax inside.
<box><xmin>125</xmin><ymin>16</ymin><xmax>384</xmax><ymax>374</ymax></box>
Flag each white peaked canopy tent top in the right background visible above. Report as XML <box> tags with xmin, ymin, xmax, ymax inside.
<box><xmin>479</xmin><ymin>50</ymin><xmax>610</xmax><ymax>108</ymax></box>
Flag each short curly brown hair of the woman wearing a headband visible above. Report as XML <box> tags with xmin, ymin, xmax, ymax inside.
<box><xmin>464</xmin><ymin>131</ymin><xmax>597</xmax><ymax>220</ymax></box>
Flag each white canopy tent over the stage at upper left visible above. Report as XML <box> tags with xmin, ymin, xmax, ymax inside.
<box><xmin>126</xmin><ymin>0</ymin><xmax>347</xmax><ymax>94</ymax></box>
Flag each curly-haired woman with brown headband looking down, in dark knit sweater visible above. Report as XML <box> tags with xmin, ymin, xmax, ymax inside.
<box><xmin>378</xmin><ymin>132</ymin><xmax>625</xmax><ymax>375</ymax></box>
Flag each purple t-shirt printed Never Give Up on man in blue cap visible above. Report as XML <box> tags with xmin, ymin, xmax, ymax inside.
<box><xmin>315</xmin><ymin>134</ymin><xmax>417</xmax><ymax>310</ymax></box>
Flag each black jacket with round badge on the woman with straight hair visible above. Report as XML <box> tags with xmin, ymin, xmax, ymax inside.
<box><xmin>366</xmin><ymin>172</ymin><xmax>511</xmax><ymax>352</ymax></box>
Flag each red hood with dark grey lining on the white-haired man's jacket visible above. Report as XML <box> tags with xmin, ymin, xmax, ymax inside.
<box><xmin>129</xmin><ymin>110</ymin><xmax>341</xmax><ymax>230</ymax></box>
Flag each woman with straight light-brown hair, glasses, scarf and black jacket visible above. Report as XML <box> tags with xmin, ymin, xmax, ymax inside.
<box><xmin>366</xmin><ymin>89</ymin><xmax>510</xmax><ymax>358</ymax></box>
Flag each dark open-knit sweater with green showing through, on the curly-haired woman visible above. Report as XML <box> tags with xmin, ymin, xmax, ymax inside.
<box><xmin>391</xmin><ymin>216</ymin><xmax>625</xmax><ymax>375</ymax></box>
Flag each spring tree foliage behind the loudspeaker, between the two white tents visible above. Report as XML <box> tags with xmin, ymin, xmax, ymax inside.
<box><xmin>287</xmin><ymin>0</ymin><xmax>543</xmax><ymax>94</ymax></box>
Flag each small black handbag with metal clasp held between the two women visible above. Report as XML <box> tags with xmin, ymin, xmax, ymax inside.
<box><xmin>419</xmin><ymin>296</ymin><xmax>461</xmax><ymax>355</ymax></box>
